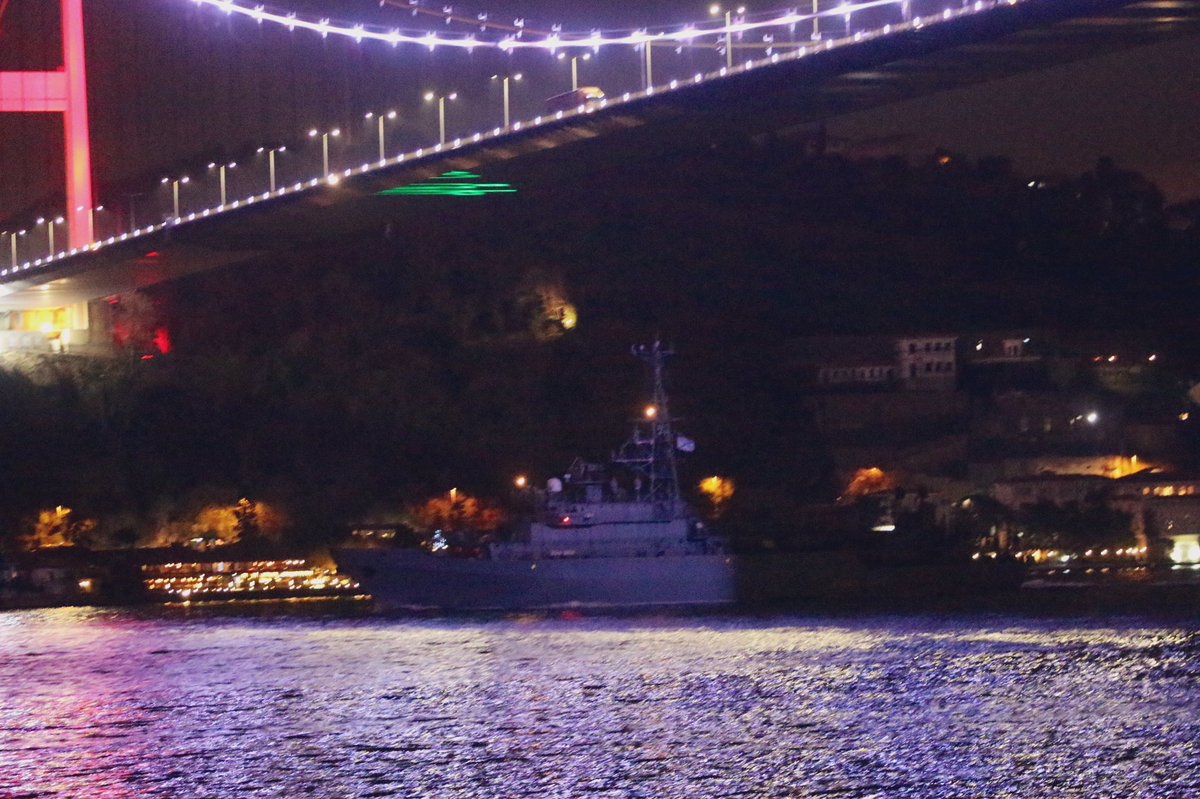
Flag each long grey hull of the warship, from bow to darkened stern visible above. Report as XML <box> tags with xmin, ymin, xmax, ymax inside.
<box><xmin>334</xmin><ymin>548</ymin><xmax>1019</xmax><ymax>611</ymax></box>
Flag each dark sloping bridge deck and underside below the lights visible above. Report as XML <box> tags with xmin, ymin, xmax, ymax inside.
<box><xmin>0</xmin><ymin>0</ymin><xmax>1200</xmax><ymax>311</ymax></box>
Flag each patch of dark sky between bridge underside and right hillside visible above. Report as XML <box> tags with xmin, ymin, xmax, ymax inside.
<box><xmin>830</xmin><ymin>33</ymin><xmax>1200</xmax><ymax>202</ymax></box>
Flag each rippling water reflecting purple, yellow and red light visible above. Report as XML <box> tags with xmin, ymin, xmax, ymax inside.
<box><xmin>0</xmin><ymin>609</ymin><xmax>1200</xmax><ymax>799</ymax></box>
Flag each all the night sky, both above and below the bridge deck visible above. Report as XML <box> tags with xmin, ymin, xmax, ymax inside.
<box><xmin>0</xmin><ymin>0</ymin><xmax>1200</xmax><ymax>224</ymax></box>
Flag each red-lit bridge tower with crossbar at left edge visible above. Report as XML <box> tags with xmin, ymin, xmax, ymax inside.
<box><xmin>0</xmin><ymin>0</ymin><xmax>92</xmax><ymax>248</ymax></box>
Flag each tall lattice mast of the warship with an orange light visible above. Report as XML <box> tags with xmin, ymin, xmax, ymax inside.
<box><xmin>613</xmin><ymin>340</ymin><xmax>679</xmax><ymax>513</ymax></box>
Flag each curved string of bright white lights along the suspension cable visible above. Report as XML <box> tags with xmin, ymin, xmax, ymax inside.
<box><xmin>192</xmin><ymin>0</ymin><xmax>908</xmax><ymax>53</ymax></box>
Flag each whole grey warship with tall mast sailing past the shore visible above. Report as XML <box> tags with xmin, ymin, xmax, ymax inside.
<box><xmin>334</xmin><ymin>342</ymin><xmax>1019</xmax><ymax>612</ymax></box>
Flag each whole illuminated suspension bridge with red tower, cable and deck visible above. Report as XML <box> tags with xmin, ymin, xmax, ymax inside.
<box><xmin>0</xmin><ymin>0</ymin><xmax>1200</xmax><ymax>350</ymax></box>
